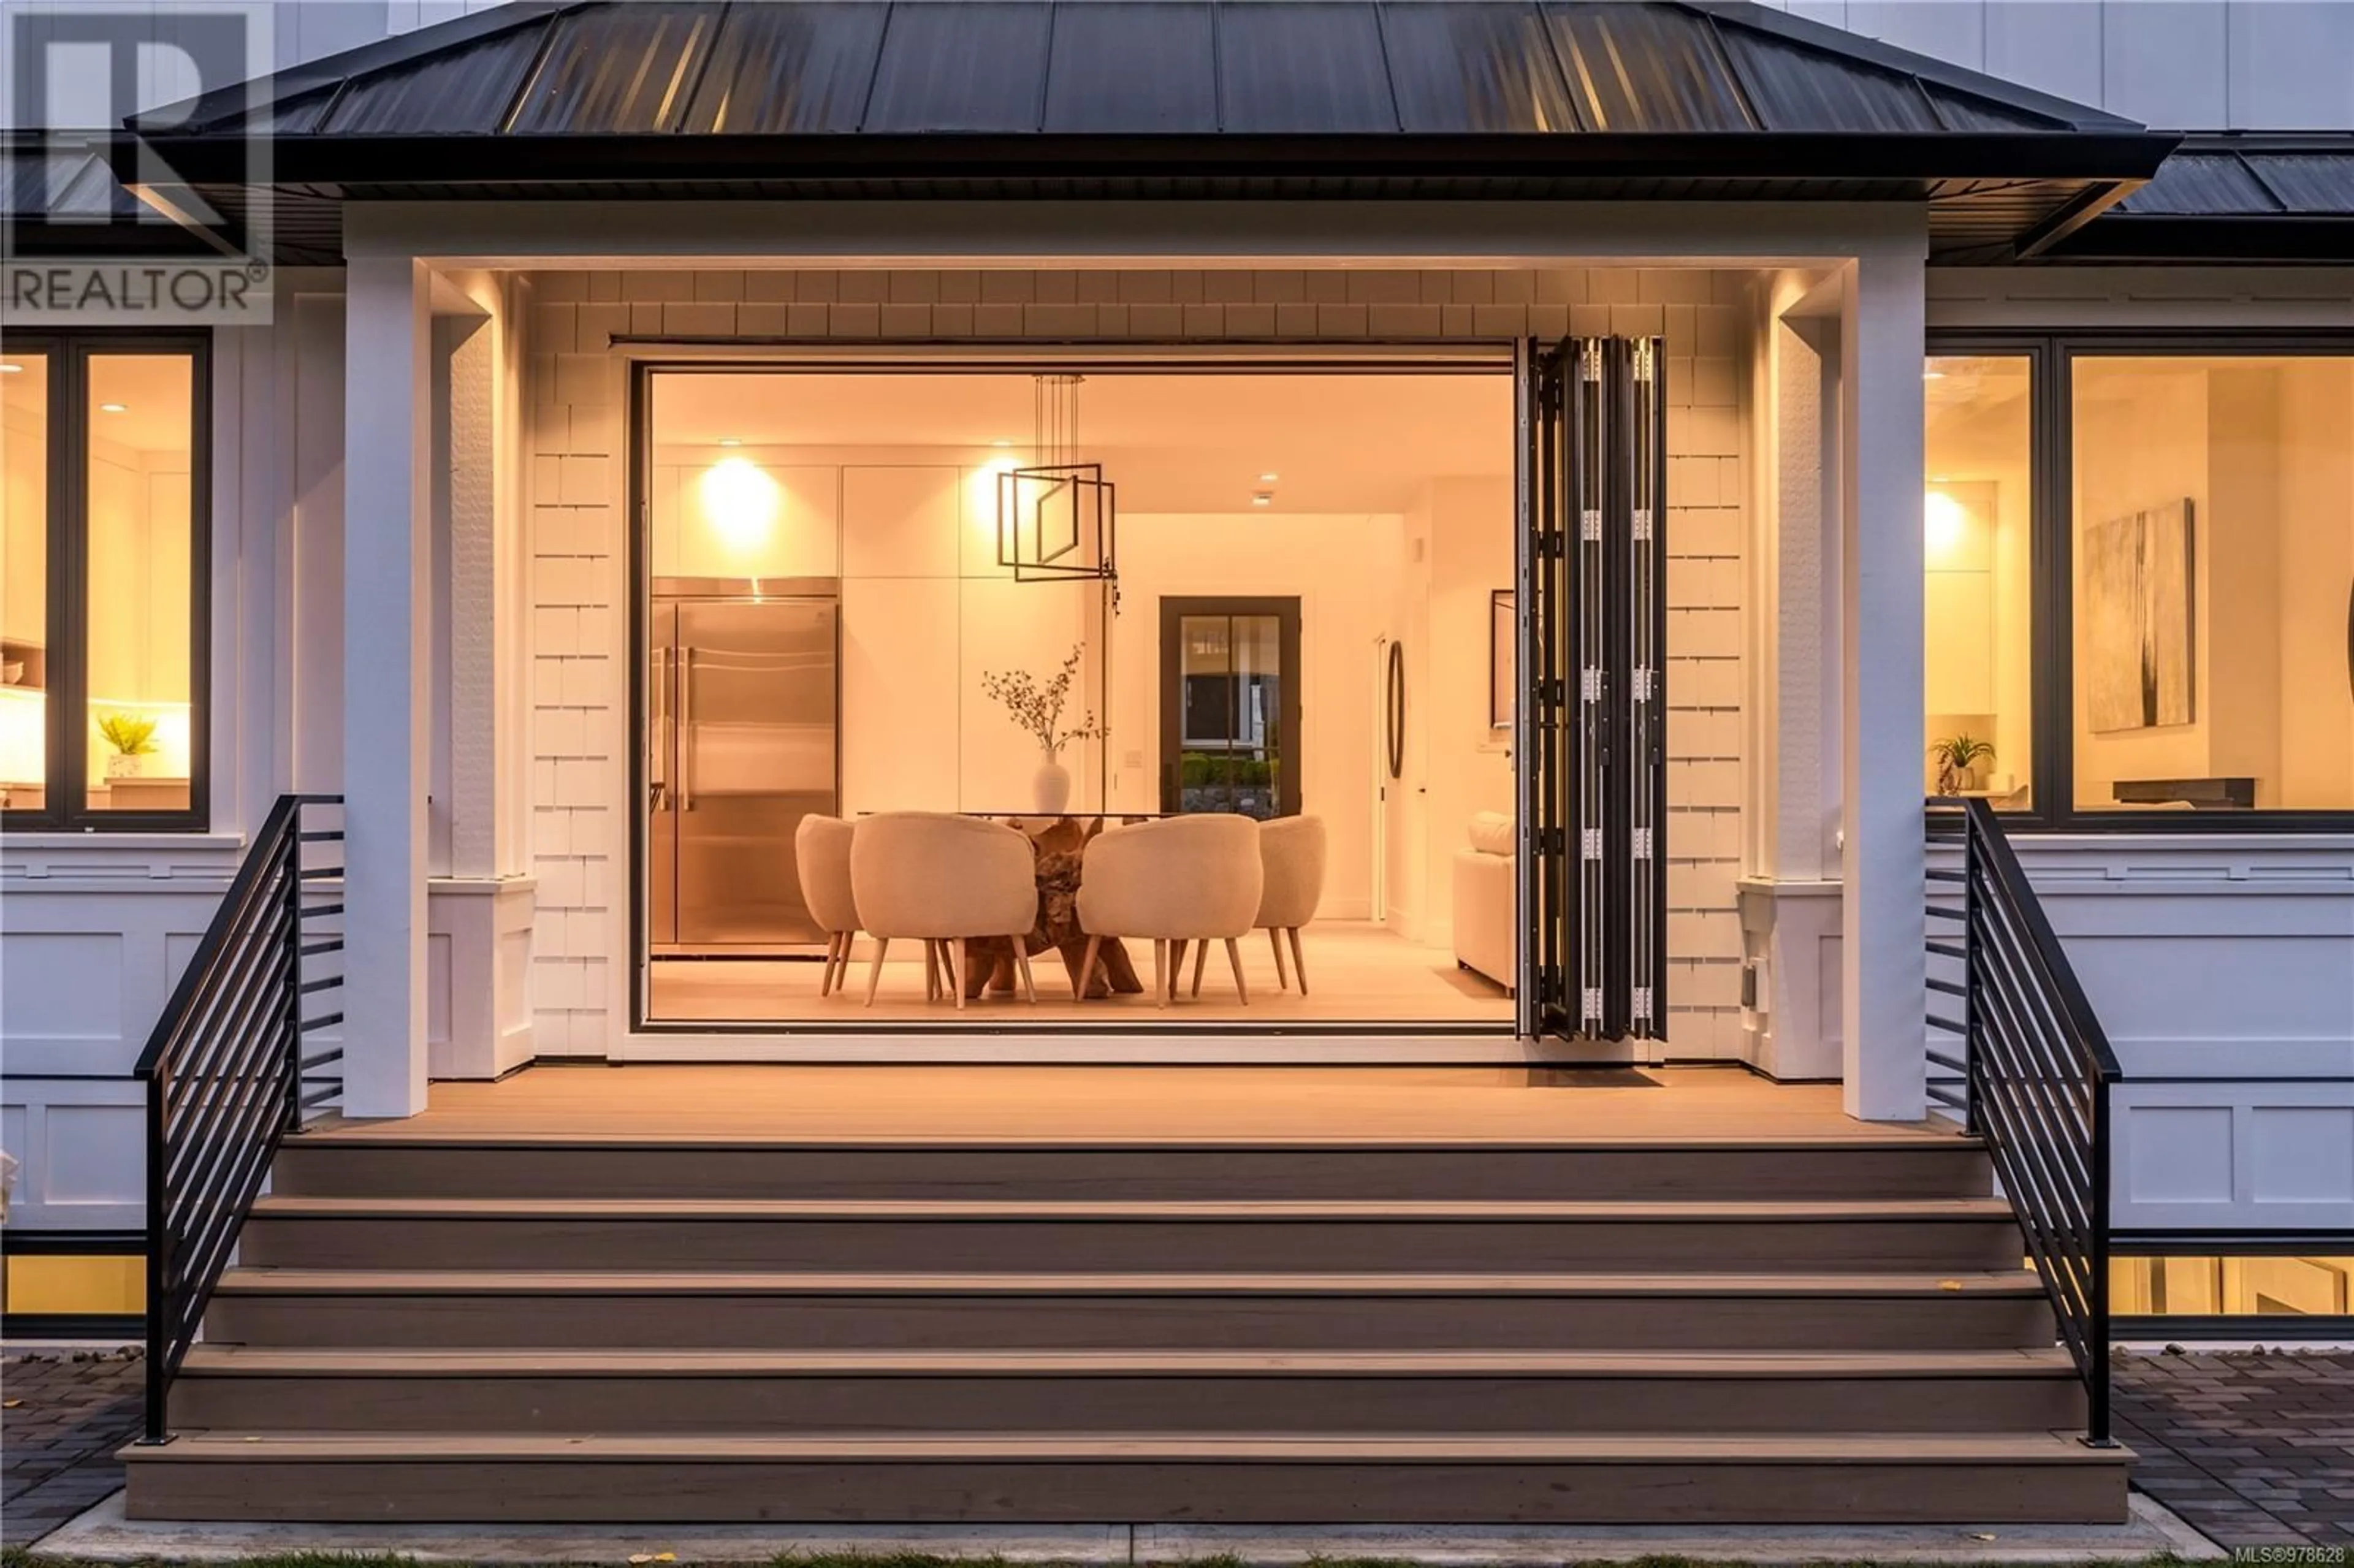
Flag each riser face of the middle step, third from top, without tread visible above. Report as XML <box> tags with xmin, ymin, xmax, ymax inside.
<box><xmin>205</xmin><ymin>1293</ymin><xmax>2055</xmax><ymax>1352</ymax></box>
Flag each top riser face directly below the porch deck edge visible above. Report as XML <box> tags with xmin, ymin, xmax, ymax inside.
<box><xmin>271</xmin><ymin>1142</ymin><xmax>1994</xmax><ymax>1201</ymax></box>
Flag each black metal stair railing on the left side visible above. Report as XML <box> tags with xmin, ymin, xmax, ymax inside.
<box><xmin>137</xmin><ymin>796</ymin><xmax>344</xmax><ymax>1443</ymax></box>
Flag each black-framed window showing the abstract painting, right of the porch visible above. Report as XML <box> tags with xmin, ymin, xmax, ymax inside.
<box><xmin>1923</xmin><ymin>332</ymin><xmax>2354</xmax><ymax>831</ymax></box>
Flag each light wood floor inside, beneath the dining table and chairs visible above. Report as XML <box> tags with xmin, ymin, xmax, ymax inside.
<box><xmin>647</xmin><ymin>921</ymin><xmax>1511</xmax><ymax>1029</ymax></box>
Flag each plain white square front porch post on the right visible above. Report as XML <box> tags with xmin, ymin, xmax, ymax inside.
<box><xmin>1838</xmin><ymin>235</ymin><xmax>1928</xmax><ymax>1121</ymax></box>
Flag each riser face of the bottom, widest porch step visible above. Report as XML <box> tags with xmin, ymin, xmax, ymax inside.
<box><xmin>129</xmin><ymin>1460</ymin><xmax>2126</xmax><ymax>1523</ymax></box>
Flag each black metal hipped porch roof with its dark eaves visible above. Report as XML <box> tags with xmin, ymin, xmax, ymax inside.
<box><xmin>96</xmin><ymin>0</ymin><xmax>2175</xmax><ymax>259</ymax></box>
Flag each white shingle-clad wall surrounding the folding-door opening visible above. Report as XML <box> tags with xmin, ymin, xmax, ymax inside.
<box><xmin>527</xmin><ymin>268</ymin><xmax>1749</xmax><ymax>1057</ymax></box>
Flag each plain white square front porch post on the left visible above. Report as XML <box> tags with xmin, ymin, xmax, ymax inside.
<box><xmin>344</xmin><ymin>257</ymin><xmax>431</xmax><ymax>1116</ymax></box>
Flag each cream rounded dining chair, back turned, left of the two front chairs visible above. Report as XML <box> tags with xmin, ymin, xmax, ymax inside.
<box><xmin>850</xmin><ymin>812</ymin><xmax>1038</xmax><ymax>1008</ymax></box>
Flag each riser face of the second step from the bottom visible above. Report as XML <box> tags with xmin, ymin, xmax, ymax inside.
<box><xmin>172</xmin><ymin>1370</ymin><xmax>2083</xmax><ymax>1436</ymax></box>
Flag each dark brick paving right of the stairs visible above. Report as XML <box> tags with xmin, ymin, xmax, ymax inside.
<box><xmin>2116</xmin><ymin>1352</ymin><xmax>2354</xmax><ymax>1547</ymax></box>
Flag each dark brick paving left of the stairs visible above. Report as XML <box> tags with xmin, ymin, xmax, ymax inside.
<box><xmin>0</xmin><ymin>1349</ymin><xmax>146</xmax><ymax>1547</ymax></box>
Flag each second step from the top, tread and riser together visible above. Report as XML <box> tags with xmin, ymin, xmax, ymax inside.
<box><xmin>243</xmin><ymin>1196</ymin><xmax>2020</xmax><ymax>1271</ymax></box>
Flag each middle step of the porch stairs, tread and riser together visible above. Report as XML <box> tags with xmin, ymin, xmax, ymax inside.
<box><xmin>207</xmin><ymin>1260</ymin><xmax>2055</xmax><ymax>1352</ymax></box>
